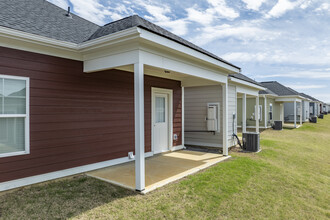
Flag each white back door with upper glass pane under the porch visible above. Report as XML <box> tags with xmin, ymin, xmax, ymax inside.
<box><xmin>153</xmin><ymin>93</ymin><xmax>169</xmax><ymax>154</ymax></box>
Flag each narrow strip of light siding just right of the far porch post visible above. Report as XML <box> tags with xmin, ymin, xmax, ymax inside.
<box><xmin>228</xmin><ymin>85</ymin><xmax>237</xmax><ymax>146</ymax></box>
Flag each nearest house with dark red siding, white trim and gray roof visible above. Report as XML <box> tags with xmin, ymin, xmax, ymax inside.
<box><xmin>0</xmin><ymin>0</ymin><xmax>242</xmax><ymax>191</ymax></box>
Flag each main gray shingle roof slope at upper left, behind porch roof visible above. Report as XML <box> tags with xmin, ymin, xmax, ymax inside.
<box><xmin>0</xmin><ymin>0</ymin><xmax>99</xmax><ymax>43</ymax></box>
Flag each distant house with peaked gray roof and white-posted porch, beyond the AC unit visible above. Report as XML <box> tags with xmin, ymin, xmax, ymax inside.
<box><xmin>260</xmin><ymin>81</ymin><xmax>305</xmax><ymax>128</ymax></box>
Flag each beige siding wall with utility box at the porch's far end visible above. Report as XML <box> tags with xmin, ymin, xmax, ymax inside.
<box><xmin>184</xmin><ymin>85</ymin><xmax>223</xmax><ymax>147</ymax></box>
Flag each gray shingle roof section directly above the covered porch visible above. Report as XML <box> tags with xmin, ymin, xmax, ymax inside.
<box><xmin>88</xmin><ymin>15</ymin><xmax>240</xmax><ymax>69</ymax></box>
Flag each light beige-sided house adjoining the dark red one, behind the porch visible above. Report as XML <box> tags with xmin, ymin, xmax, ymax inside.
<box><xmin>184</xmin><ymin>73</ymin><xmax>263</xmax><ymax>148</ymax></box>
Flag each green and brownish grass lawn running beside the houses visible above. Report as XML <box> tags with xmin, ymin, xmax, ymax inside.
<box><xmin>0</xmin><ymin>115</ymin><xmax>330</xmax><ymax>219</ymax></box>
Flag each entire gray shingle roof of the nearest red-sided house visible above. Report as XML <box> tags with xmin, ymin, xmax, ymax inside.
<box><xmin>0</xmin><ymin>0</ymin><xmax>240</xmax><ymax>69</ymax></box>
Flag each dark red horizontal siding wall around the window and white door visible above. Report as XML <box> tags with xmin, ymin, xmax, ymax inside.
<box><xmin>0</xmin><ymin>48</ymin><xmax>181</xmax><ymax>182</ymax></box>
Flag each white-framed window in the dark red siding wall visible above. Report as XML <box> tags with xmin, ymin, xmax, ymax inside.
<box><xmin>0</xmin><ymin>75</ymin><xmax>29</xmax><ymax>157</ymax></box>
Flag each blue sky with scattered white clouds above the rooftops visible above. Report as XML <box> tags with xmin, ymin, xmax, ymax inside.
<box><xmin>48</xmin><ymin>0</ymin><xmax>330</xmax><ymax>103</ymax></box>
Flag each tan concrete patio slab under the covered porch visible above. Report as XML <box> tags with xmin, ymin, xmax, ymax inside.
<box><xmin>87</xmin><ymin>150</ymin><xmax>229</xmax><ymax>193</ymax></box>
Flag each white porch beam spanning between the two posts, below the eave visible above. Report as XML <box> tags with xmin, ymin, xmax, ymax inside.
<box><xmin>140</xmin><ymin>50</ymin><xmax>227</xmax><ymax>83</ymax></box>
